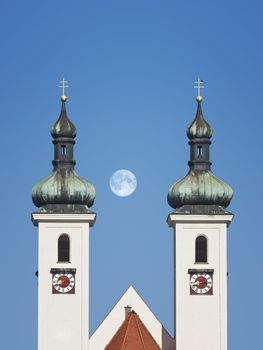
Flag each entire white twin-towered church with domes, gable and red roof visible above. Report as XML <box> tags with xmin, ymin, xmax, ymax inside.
<box><xmin>32</xmin><ymin>79</ymin><xmax>233</xmax><ymax>350</ymax></box>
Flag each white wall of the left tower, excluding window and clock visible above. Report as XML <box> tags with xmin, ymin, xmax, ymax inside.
<box><xmin>32</xmin><ymin>213</ymin><xmax>95</xmax><ymax>350</ymax></box>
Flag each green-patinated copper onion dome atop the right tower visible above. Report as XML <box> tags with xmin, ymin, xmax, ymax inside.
<box><xmin>167</xmin><ymin>88</ymin><xmax>233</xmax><ymax>214</ymax></box>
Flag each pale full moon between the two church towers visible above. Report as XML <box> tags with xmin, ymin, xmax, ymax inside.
<box><xmin>110</xmin><ymin>169</ymin><xmax>137</xmax><ymax>197</ymax></box>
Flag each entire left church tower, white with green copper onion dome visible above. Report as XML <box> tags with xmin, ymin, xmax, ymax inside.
<box><xmin>32</xmin><ymin>79</ymin><xmax>96</xmax><ymax>350</ymax></box>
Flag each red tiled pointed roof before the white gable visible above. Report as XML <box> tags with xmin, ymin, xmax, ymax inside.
<box><xmin>105</xmin><ymin>311</ymin><xmax>161</xmax><ymax>350</ymax></box>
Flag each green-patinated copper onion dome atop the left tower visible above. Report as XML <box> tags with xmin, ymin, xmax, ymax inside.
<box><xmin>32</xmin><ymin>95</ymin><xmax>96</xmax><ymax>213</ymax></box>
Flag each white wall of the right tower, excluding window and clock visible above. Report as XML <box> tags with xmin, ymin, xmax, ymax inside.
<box><xmin>168</xmin><ymin>214</ymin><xmax>233</xmax><ymax>350</ymax></box>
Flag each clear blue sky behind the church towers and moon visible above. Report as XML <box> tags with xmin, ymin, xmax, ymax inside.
<box><xmin>0</xmin><ymin>0</ymin><xmax>263</xmax><ymax>350</ymax></box>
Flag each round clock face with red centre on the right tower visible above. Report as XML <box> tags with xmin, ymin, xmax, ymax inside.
<box><xmin>190</xmin><ymin>272</ymin><xmax>213</xmax><ymax>295</ymax></box>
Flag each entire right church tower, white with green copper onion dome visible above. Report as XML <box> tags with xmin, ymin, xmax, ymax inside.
<box><xmin>168</xmin><ymin>79</ymin><xmax>233</xmax><ymax>350</ymax></box>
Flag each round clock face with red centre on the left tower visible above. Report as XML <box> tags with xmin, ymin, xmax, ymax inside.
<box><xmin>52</xmin><ymin>272</ymin><xmax>75</xmax><ymax>294</ymax></box>
